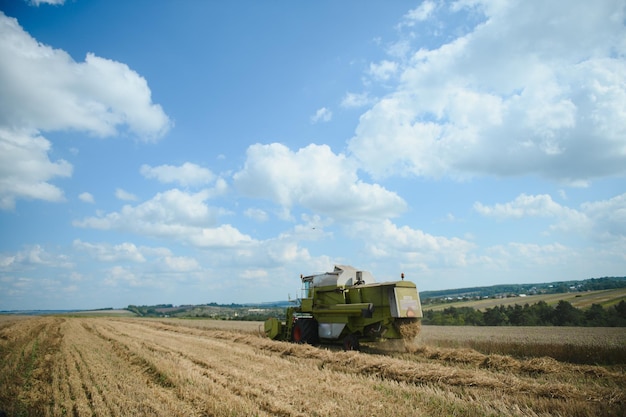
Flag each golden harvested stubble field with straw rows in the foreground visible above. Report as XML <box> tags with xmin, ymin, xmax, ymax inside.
<box><xmin>0</xmin><ymin>317</ymin><xmax>626</xmax><ymax>417</ymax></box>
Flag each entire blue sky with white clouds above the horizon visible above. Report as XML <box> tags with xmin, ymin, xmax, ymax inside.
<box><xmin>0</xmin><ymin>0</ymin><xmax>626</xmax><ymax>310</ymax></box>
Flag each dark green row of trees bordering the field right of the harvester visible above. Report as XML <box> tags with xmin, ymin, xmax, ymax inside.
<box><xmin>422</xmin><ymin>300</ymin><xmax>626</xmax><ymax>327</ymax></box>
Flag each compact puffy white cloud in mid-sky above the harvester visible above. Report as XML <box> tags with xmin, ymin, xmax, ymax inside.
<box><xmin>233</xmin><ymin>143</ymin><xmax>406</xmax><ymax>220</ymax></box>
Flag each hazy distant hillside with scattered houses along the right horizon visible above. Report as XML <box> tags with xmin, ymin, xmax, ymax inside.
<box><xmin>420</xmin><ymin>277</ymin><xmax>626</xmax><ymax>305</ymax></box>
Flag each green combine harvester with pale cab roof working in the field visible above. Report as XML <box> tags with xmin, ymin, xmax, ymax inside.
<box><xmin>265</xmin><ymin>265</ymin><xmax>422</xmax><ymax>350</ymax></box>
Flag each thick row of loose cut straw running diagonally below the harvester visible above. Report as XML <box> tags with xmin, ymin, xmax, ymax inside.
<box><xmin>129</xmin><ymin>316</ymin><xmax>626</xmax><ymax>402</ymax></box>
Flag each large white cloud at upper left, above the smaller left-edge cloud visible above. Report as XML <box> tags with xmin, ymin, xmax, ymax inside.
<box><xmin>0</xmin><ymin>14</ymin><xmax>171</xmax><ymax>140</ymax></box>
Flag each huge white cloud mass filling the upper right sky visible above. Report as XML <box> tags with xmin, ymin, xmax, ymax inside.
<box><xmin>349</xmin><ymin>0</ymin><xmax>626</xmax><ymax>183</ymax></box>
